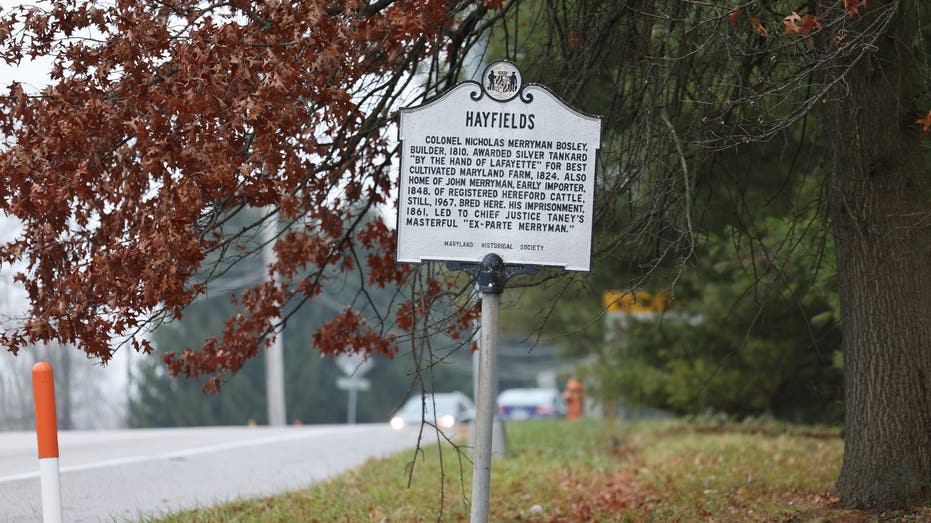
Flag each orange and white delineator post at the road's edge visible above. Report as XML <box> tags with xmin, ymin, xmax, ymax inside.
<box><xmin>32</xmin><ymin>361</ymin><xmax>62</xmax><ymax>523</ymax></box>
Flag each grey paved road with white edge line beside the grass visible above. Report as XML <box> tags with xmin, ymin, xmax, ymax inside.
<box><xmin>0</xmin><ymin>424</ymin><xmax>416</xmax><ymax>523</ymax></box>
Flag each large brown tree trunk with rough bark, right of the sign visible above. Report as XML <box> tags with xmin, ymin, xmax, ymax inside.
<box><xmin>824</xmin><ymin>2</ymin><xmax>931</xmax><ymax>507</ymax></box>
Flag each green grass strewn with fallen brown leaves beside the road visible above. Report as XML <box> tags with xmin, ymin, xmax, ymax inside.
<box><xmin>150</xmin><ymin>420</ymin><xmax>931</xmax><ymax>523</ymax></box>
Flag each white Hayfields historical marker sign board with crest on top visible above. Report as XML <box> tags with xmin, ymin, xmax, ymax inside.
<box><xmin>397</xmin><ymin>61</ymin><xmax>601</xmax><ymax>271</ymax></box>
